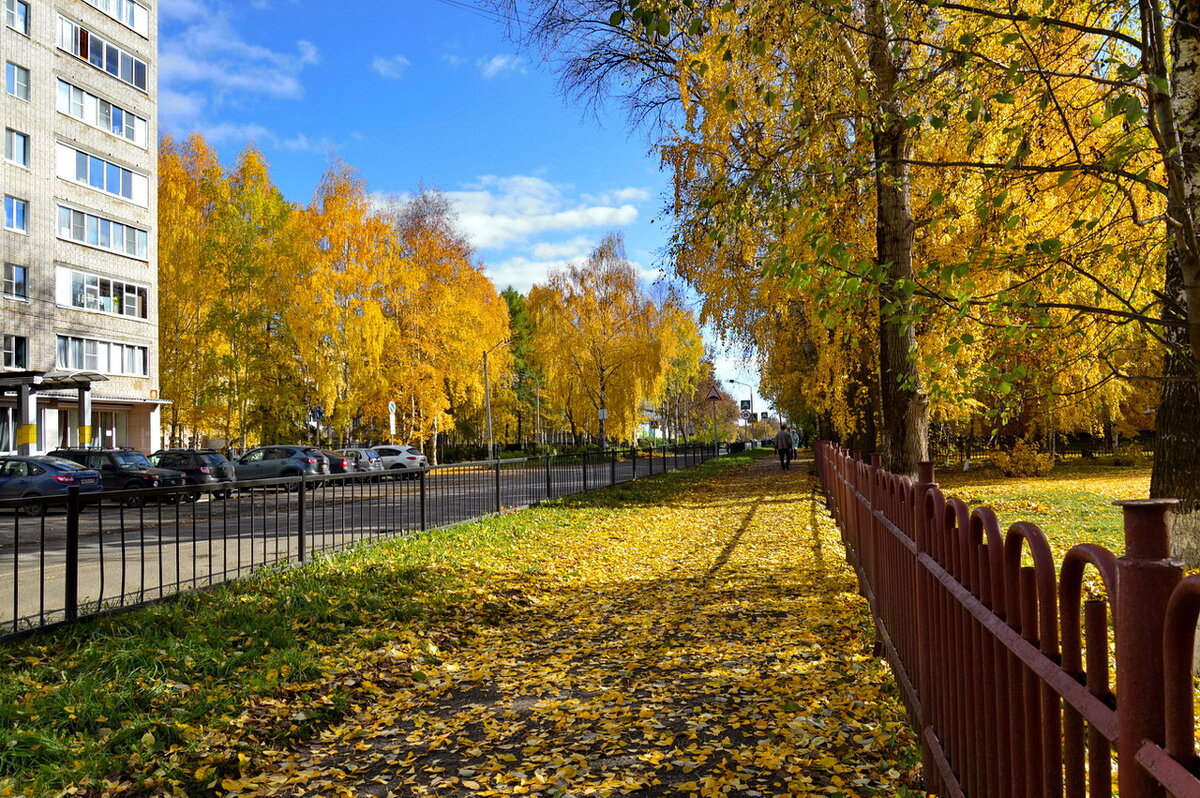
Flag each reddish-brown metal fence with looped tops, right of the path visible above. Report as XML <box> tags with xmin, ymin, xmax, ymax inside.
<box><xmin>816</xmin><ymin>442</ymin><xmax>1200</xmax><ymax>798</ymax></box>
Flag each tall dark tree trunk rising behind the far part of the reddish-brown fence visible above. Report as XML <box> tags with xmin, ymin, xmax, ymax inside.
<box><xmin>865</xmin><ymin>0</ymin><xmax>929</xmax><ymax>476</ymax></box>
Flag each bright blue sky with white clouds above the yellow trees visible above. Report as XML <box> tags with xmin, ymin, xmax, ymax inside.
<box><xmin>158</xmin><ymin>0</ymin><xmax>764</xmax><ymax>409</ymax></box>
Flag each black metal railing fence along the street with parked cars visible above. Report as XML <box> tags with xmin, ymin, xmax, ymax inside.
<box><xmin>0</xmin><ymin>444</ymin><xmax>720</xmax><ymax>640</ymax></box>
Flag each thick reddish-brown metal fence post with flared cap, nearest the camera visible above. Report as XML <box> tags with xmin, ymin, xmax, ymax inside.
<box><xmin>1114</xmin><ymin>499</ymin><xmax>1183</xmax><ymax>798</ymax></box>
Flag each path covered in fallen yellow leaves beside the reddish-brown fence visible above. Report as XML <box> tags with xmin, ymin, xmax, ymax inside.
<box><xmin>224</xmin><ymin>460</ymin><xmax>916</xmax><ymax>796</ymax></box>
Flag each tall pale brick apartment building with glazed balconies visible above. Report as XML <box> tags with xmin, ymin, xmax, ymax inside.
<box><xmin>0</xmin><ymin>0</ymin><xmax>162</xmax><ymax>451</ymax></box>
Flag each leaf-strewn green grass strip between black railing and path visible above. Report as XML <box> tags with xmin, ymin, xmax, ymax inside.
<box><xmin>0</xmin><ymin>455</ymin><xmax>749</xmax><ymax>797</ymax></box>
